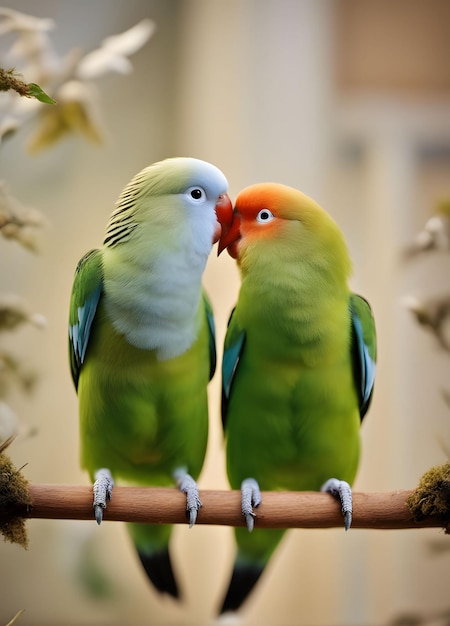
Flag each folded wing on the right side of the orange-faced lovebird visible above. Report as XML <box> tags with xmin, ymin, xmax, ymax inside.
<box><xmin>350</xmin><ymin>294</ymin><xmax>377</xmax><ymax>420</ymax></box>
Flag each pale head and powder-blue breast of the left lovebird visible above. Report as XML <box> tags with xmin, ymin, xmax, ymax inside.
<box><xmin>102</xmin><ymin>158</ymin><xmax>231</xmax><ymax>359</ymax></box>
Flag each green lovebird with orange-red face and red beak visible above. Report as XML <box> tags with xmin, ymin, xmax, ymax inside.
<box><xmin>214</xmin><ymin>183</ymin><xmax>376</xmax><ymax>613</ymax></box>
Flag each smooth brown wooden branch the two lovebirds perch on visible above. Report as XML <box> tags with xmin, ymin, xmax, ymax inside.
<box><xmin>0</xmin><ymin>484</ymin><xmax>443</xmax><ymax>529</ymax></box>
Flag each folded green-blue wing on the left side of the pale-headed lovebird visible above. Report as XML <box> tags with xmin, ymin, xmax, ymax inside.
<box><xmin>69</xmin><ymin>250</ymin><xmax>103</xmax><ymax>389</ymax></box>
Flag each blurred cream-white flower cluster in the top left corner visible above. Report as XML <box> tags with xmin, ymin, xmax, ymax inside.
<box><xmin>0</xmin><ymin>7</ymin><xmax>155</xmax><ymax>153</ymax></box>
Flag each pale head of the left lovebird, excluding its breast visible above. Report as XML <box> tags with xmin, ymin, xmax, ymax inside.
<box><xmin>104</xmin><ymin>157</ymin><xmax>231</xmax><ymax>255</ymax></box>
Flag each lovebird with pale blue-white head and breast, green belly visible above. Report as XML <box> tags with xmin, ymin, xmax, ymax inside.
<box><xmin>69</xmin><ymin>158</ymin><xmax>231</xmax><ymax>598</ymax></box>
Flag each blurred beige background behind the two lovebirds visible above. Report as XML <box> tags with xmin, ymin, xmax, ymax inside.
<box><xmin>0</xmin><ymin>0</ymin><xmax>450</xmax><ymax>626</ymax></box>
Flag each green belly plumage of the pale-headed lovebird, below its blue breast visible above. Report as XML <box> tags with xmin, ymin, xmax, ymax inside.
<box><xmin>73</xmin><ymin>264</ymin><xmax>211</xmax><ymax>486</ymax></box>
